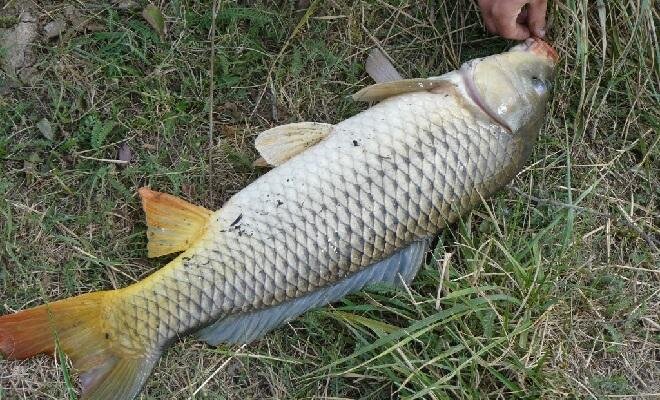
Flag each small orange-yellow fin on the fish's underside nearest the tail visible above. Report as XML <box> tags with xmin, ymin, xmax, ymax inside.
<box><xmin>138</xmin><ymin>187</ymin><xmax>212</xmax><ymax>257</ymax></box>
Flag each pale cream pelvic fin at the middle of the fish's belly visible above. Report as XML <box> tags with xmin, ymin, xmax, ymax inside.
<box><xmin>254</xmin><ymin>122</ymin><xmax>332</xmax><ymax>166</ymax></box>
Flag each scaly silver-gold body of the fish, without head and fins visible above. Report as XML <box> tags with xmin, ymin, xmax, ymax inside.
<box><xmin>108</xmin><ymin>89</ymin><xmax>522</xmax><ymax>349</ymax></box>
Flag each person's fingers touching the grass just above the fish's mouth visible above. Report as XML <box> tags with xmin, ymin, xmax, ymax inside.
<box><xmin>478</xmin><ymin>0</ymin><xmax>548</xmax><ymax>40</ymax></box>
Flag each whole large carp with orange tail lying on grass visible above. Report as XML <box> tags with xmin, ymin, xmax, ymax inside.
<box><xmin>0</xmin><ymin>39</ymin><xmax>558</xmax><ymax>400</ymax></box>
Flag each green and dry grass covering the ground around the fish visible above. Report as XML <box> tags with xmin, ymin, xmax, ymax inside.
<box><xmin>0</xmin><ymin>0</ymin><xmax>660</xmax><ymax>399</ymax></box>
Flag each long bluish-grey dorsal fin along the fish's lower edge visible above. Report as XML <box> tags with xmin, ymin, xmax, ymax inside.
<box><xmin>197</xmin><ymin>239</ymin><xmax>429</xmax><ymax>346</ymax></box>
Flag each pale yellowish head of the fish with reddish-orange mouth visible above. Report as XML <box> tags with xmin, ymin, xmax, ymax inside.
<box><xmin>461</xmin><ymin>38</ymin><xmax>559</xmax><ymax>138</ymax></box>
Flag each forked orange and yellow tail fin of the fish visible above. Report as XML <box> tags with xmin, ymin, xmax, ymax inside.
<box><xmin>0</xmin><ymin>292</ymin><xmax>159</xmax><ymax>400</ymax></box>
